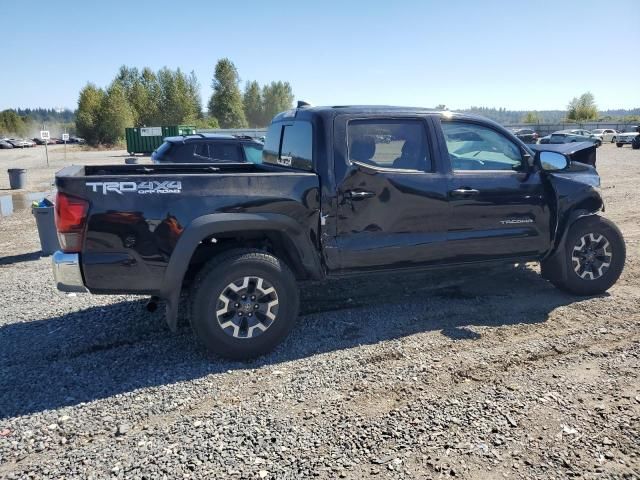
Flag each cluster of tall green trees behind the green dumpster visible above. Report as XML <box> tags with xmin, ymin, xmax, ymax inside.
<box><xmin>76</xmin><ymin>58</ymin><xmax>293</xmax><ymax>145</ymax></box>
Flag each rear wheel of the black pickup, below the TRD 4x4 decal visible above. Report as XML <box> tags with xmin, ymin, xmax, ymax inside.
<box><xmin>190</xmin><ymin>250</ymin><xmax>298</xmax><ymax>360</ymax></box>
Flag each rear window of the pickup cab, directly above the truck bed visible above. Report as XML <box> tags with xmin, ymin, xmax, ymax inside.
<box><xmin>262</xmin><ymin>122</ymin><xmax>313</xmax><ymax>170</ymax></box>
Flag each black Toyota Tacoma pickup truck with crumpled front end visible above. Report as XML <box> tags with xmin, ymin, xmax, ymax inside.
<box><xmin>53</xmin><ymin>105</ymin><xmax>625</xmax><ymax>358</ymax></box>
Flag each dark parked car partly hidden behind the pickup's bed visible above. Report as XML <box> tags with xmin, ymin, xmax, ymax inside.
<box><xmin>151</xmin><ymin>133</ymin><xmax>264</xmax><ymax>163</ymax></box>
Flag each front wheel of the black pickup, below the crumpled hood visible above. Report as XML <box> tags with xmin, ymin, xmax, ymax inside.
<box><xmin>554</xmin><ymin>216</ymin><xmax>626</xmax><ymax>295</ymax></box>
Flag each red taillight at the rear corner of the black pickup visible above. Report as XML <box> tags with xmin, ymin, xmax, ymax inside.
<box><xmin>56</xmin><ymin>192</ymin><xmax>89</xmax><ymax>253</ymax></box>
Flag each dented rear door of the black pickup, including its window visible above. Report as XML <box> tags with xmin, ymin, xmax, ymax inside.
<box><xmin>336</xmin><ymin>116</ymin><xmax>449</xmax><ymax>272</ymax></box>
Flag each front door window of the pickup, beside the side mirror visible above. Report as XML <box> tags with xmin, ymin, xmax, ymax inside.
<box><xmin>442</xmin><ymin>121</ymin><xmax>523</xmax><ymax>171</ymax></box>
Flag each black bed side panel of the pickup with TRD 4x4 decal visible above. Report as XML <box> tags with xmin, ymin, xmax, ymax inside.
<box><xmin>56</xmin><ymin>163</ymin><xmax>320</xmax><ymax>295</ymax></box>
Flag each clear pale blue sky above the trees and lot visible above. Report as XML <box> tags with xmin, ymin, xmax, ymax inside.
<box><xmin>0</xmin><ymin>0</ymin><xmax>640</xmax><ymax>110</ymax></box>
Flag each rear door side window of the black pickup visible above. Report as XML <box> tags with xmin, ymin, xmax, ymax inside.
<box><xmin>347</xmin><ymin>119</ymin><xmax>431</xmax><ymax>171</ymax></box>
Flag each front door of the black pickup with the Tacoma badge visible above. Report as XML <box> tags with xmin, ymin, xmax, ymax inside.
<box><xmin>440</xmin><ymin>119</ymin><xmax>551</xmax><ymax>262</ymax></box>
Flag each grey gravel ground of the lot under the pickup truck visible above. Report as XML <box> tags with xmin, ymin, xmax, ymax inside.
<box><xmin>0</xmin><ymin>145</ymin><xmax>640</xmax><ymax>479</ymax></box>
